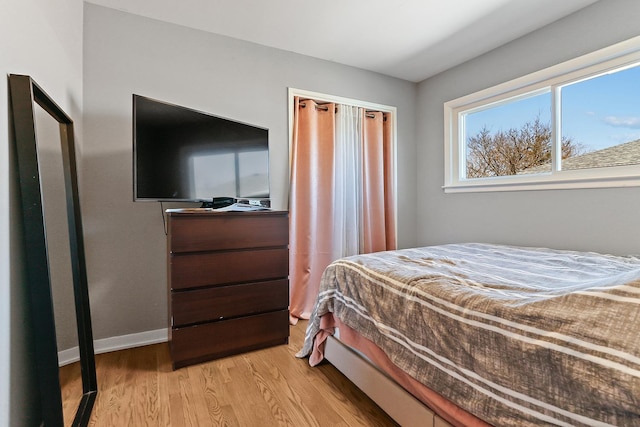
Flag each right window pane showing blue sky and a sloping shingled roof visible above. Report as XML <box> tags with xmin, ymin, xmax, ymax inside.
<box><xmin>561</xmin><ymin>66</ymin><xmax>640</xmax><ymax>170</ymax></box>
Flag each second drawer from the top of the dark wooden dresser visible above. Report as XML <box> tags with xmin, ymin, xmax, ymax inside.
<box><xmin>170</xmin><ymin>248</ymin><xmax>289</xmax><ymax>290</ymax></box>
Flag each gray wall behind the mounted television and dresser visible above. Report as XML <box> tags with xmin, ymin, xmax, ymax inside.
<box><xmin>82</xmin><ymin>4</ymin><xmax>417</xmax><ymax>339</ymax></box>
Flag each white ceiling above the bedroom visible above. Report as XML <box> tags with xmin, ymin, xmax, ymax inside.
<box><xmin>87</xmin><ymin>0</ymin><xmax>596</xmax><ymax>82</ymax></box>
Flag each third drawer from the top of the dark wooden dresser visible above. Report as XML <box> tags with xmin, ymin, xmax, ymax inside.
<box><xmin>171</xmin><ymin>279</ymin><xmax>289</xmax><ymax>327</ymax></box>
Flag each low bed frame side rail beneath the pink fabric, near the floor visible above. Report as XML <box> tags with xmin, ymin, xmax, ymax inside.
<box><xmin>324</xmin><ymin>336</ymin><xmax>451</xmax><ymax>427</ymax></box>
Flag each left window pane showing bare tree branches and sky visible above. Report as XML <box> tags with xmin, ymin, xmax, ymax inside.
<box><xmin>462</xmin><ymin>91</ymin><xmax>552</xmax><ymax>179</ymax></box>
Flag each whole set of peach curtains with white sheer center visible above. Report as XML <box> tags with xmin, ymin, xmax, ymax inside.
<box><xmin>289</xmin><ymin>97</ymin><xmax>396</xmax><ymax>323</ymax></box>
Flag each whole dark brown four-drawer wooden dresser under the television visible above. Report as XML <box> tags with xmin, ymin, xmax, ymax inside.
<box><xmin>167</xmin><ymin>210</ymin><xmax>289</xmax><ymax>369</ymax></box>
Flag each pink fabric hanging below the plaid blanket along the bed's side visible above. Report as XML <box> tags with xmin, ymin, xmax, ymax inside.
<box><xmin>309</xmin><ymin>313</ymin><xmax>490</xmax><ymax>427</ymax></box>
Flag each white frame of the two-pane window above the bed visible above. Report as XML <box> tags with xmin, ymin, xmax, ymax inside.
<box><xmin>443</xmin><ymin>37</ymin><xmax>640</xmax><ymax>193</ymax></box>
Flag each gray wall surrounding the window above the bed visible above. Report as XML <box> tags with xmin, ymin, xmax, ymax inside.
<box><xmin>417</xmin><ymin>0</ymin><xmax>640</xmax><ymax>254</ymax></box>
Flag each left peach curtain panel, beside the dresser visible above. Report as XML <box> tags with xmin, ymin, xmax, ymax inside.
<box><xmin>289</xmin><ymin>97</ymin><xmax>335</xmax><ymax>320</ymax></box>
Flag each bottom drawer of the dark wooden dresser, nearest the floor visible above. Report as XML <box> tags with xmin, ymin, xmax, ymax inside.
<box><xmin>170</xmin><ymin>310</ymin><xmax>289</xmax><ymax>369</ymax></box>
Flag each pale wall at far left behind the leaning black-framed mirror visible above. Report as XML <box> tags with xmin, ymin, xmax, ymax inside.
<box><xmin>0</xmin><ymin>0</ymin><xmax>82</xmax><ymax>427</ymax></box>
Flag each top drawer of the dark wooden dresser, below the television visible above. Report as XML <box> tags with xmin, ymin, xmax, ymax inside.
<box><xmin>169</xmin><ymin>212</ymin><xmax>289</xmax><ymax>253</ymax></box>
